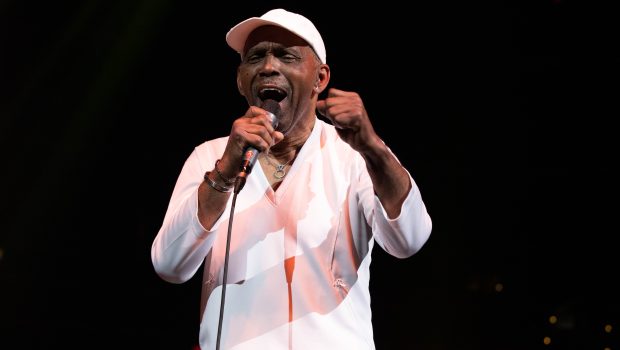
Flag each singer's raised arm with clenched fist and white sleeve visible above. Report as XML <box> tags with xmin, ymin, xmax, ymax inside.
<box><xmin>317</xmin><ymin>88</ymin><xmax>432</xmax><ymax>258</ymax></box>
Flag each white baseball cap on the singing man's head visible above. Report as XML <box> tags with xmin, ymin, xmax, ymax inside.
<box><xmin>226</xmin><ymin>9</ymin><xmax>327</xmax><ymax>63</ymax></box>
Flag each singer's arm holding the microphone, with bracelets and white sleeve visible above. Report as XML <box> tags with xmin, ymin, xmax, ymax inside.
<box><xmin>151</xmin><ymin>107</ymin><xmax>283</xmax><ymax>283</ymax></box>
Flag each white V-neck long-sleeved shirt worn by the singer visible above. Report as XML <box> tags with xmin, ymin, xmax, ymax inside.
<box><xmin>151</xmin><ymin>119</ymin><xmax>432</xmax><ymax>350</ymax></box>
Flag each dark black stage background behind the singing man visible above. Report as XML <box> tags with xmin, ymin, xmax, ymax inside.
<box><xmin>0</xmin><ymin>0</ymin><xmax>620</xmax><ymax>350</ymax></box>
